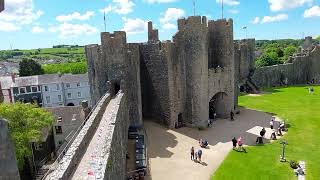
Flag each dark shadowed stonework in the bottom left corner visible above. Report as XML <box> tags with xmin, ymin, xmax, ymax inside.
<box><xmin>0</xmin><ymin>119</ymin><xmax>20</xmax><ymax>180</ymax></box>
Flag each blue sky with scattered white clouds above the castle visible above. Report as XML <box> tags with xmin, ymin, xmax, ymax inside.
<box><xmin>0</xmin><ymin>0</ymin><xmax>320</xmax><ymax>49</ymax></box>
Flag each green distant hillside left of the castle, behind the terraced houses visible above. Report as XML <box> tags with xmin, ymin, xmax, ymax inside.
<box><xmin>0</xmin><ymin>45</ymin><xmax>87</xmax><ymax>75</ymax></box>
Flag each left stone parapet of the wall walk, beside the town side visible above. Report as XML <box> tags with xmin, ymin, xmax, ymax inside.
<box><xmin>45</xmin><ymin>94</ymin><xmax>111</xmax><ymax>180</ymax></box>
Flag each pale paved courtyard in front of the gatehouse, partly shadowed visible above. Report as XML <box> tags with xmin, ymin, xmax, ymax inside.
<box><xmin>144</xmin><ymin>109</ymin><xmax>284</xmax><ymax>180</ymax></box>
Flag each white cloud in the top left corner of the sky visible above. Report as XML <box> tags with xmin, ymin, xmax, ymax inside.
<box><xmin>0</xmin><ymin>0</ymin><xmax>44</xmax><ymax>26</ymax></box>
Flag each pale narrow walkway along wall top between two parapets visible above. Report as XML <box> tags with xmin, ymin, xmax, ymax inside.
<box><xmin>71</xmin><ymin>96</ymin><xmax>119</xmax><ymax>180</ymax></box>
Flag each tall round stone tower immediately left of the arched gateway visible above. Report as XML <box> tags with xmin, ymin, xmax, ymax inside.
<box><xmin>174</xmin><ymin>16</ymin><xmax>209</xmax><ymax>127</ymax></box>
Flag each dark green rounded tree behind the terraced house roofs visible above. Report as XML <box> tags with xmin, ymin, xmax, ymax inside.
<box><xmin>19</xmin><ymin>58</ymin><xmax>44</xmax><ymax>76</ymax></box>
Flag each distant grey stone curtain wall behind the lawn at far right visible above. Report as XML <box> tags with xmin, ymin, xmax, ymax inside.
<box><xmin>251</xmin><ymin>46</ymin><xmax>320</xmax><ymax>87</ymax></box>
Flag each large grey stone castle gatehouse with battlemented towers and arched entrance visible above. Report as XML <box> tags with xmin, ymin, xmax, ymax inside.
<box><xmin>86</xmin><ymin>16</ymin><xmax>236</xmax><ymax>128</ymax></box>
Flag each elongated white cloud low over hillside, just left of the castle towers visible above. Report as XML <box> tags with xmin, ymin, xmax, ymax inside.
<box><xmin>49</xmin><ymin>23</ymin><xmax>98</xmax><ymax>39</ymax></box>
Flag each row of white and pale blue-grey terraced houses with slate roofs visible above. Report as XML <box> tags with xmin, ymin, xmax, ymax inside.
<box><xmin>0</xmin><ymin>74</ymin><xmax>91</xmax><ymax>107</ymax></box>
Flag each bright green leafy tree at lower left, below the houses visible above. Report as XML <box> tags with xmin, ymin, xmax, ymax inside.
<box><xmin>0</xmin><ymin>103</ymin><xmax>53</xmax><ymax>170</ymax></box>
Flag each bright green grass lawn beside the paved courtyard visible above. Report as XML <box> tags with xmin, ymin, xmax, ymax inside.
<box><xmin>212</xmin><ymin>86</ymin><xmax>320</xmax><ymax>180</ymax></box>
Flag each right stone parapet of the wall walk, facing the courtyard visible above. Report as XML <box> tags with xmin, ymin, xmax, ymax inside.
<box><xmin>104</xmin><ymin>93</ymin><xmax>129</xmax><ymax>180</ymax></box>
